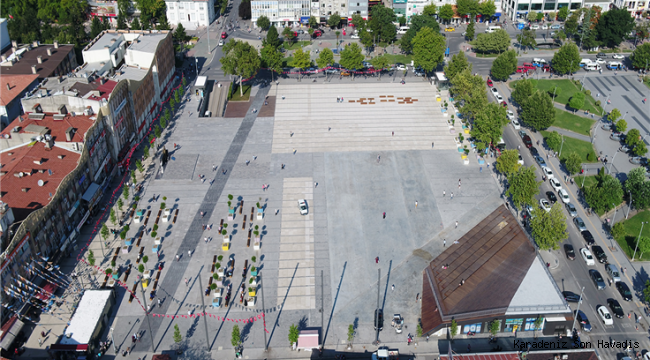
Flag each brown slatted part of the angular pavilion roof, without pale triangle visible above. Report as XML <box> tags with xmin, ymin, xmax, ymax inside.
<box><xmin>422</xmin><ymin>206</ymin><xmax>536</xmax><ymax>329</ymax></box>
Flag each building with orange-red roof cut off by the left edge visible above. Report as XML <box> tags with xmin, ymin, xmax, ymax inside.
<box><xmin>0</xmin><ymin>74</ymin><xmax>38</xmax><ymax>129</ymax></box>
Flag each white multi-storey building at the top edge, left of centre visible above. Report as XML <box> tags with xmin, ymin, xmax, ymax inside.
<box><xmin>165</xmin><ymin>0</ymin><xmax>216</xmax><ymax>30</ymax></box>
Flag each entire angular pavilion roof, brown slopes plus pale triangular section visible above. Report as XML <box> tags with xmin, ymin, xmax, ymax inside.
<box><xmin>422</xmin><ymin>206</ymin><xmax>570</xmax><ymax>332</ymax></box>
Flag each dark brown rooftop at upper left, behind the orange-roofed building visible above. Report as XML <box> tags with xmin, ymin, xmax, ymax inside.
<box><xmin>0</xmin><ymin>44</ymin><xmax>74</xmax><ymax>78</ymax></box>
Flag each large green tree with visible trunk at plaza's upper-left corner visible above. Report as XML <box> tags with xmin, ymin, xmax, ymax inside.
<box><xmin>219</xmin><ymin>39</ymin><xmax>261</xmax><ymax>96</ymax></box>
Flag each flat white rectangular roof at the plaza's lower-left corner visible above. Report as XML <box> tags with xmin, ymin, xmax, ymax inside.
<box><xmin>59</xmin><ymin>290</ymin><xmax>111</xmax><ymax>345</ymax></box>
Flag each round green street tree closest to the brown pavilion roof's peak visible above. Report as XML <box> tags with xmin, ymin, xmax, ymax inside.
<box><xmin>529</xmin><ymin>202</ymin><xmax>569</xmax><ymax>250</ymax></box>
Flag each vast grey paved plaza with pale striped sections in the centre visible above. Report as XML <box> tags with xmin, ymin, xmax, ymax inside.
<box><xmin>105</xmin><ymin>82</ymin><xmax>502</xmax><ymax>358</ymax></box>
